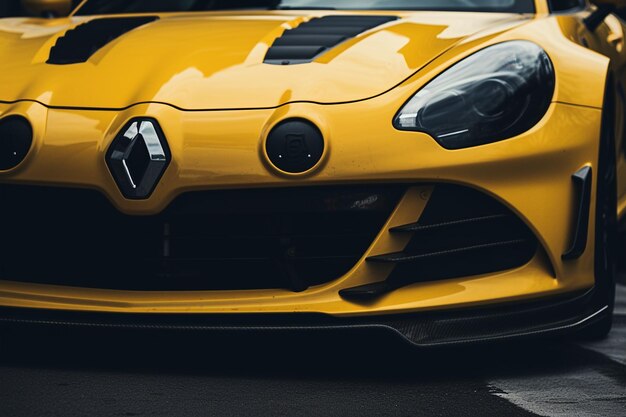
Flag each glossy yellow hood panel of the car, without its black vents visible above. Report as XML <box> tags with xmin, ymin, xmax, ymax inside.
<box><xmin>0</xmin><ymin>12</ymin><xmax>529</xmax><ymax>109</ymax></box>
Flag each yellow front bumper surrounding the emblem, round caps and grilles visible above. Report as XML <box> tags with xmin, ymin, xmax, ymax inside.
<box><xmin>0</xmin><ymin>96</ymin><xmax>601</xmax><ymax>317</ymax></box>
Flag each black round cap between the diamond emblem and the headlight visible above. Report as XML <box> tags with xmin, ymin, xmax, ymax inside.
<box><xmin>265</xmin><ymin>119</ymin><xmax>324</xmax><ymax>174</ymax></box>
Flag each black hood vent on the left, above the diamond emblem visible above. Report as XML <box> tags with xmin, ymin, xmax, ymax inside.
<box><xmin>48</xmin><ymin>16</ymin><xmax>158</xmax><ymax>65</ymax></box>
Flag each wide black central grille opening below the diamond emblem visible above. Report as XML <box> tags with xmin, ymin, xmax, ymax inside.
<box><xmin>0</xmin><ymin>185</ymin><xmax>404</xmax><ymax>291</ymax></box>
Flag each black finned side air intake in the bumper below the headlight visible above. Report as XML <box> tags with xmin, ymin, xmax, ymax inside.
<box><xmin>366</xmin><ymin>184</ymin><xmax>538</xmax><ymax>294</ymax></box>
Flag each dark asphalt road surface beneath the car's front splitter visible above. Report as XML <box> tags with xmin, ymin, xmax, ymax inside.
<box><xmin>0</xmin><ymin>278</ymin><xmax>626</xmax><ymax>417</ymax></box>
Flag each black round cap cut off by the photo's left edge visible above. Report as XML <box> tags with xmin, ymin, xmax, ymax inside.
<box><xmin>0</xmin><ymin>116</ymin><xmax>33</xmax><ymax>170</ymax></box>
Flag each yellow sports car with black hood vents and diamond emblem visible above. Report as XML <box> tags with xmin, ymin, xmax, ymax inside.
<box><xmin>0</xmin><ymin>0</ymin><xmax>626</xmax><ymax>346</ymax></box>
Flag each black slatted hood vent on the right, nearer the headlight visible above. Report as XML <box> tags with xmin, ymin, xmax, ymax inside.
<box><xmin>265</xmin><ymin>16</ymin><xmax>398</xmax><ymax>65</ymax></box>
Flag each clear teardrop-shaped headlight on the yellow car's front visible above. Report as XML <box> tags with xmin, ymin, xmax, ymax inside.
<box><xmin>394</xmin><ymin>41</ymin><xmax>554</xmax><ymax>149</ymax></box>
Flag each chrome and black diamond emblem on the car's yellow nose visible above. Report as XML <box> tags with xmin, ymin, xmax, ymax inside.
<box><xmin>106</xmin><ymin>119</ymin><xmax>171</xmax><ymax>199</ymax></box>
